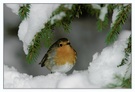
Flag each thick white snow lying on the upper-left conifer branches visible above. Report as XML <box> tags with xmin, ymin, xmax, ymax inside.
<box><xmin>8</xmin><ymin>4</ymin><xmax>60</xmax><ymax>54</ymax></box>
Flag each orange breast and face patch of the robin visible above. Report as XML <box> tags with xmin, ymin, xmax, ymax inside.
<box><xmin>55</xmin><ymin>45</ymin><xmax>76</xmax><ymax>65</ymax></box>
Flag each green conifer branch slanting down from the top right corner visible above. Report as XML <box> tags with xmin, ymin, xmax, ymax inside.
<box><xmin>106</xmin><ymin>4</ymin><xmax>131</xmax><ymax>44</ymax></box>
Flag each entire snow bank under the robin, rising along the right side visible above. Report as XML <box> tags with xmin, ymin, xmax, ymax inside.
<box><xmin>4</xmin><ymin>31</ymin><xmax>131</xmax><ymax>88</ymax></box>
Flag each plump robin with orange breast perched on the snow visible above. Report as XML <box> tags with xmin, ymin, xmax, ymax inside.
<box><xmin>39</xmin><ymin>38</ymin><xmax>77</xmax><ymax>73</ymax></box>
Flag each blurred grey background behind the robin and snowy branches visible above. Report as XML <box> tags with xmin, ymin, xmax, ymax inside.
<box><xmin>3</xmin><ymin>4</ymin><xmax>131</xmax><ymax>76</ymax></box>
